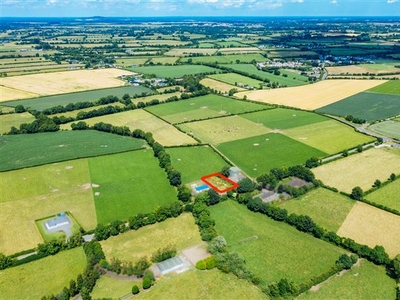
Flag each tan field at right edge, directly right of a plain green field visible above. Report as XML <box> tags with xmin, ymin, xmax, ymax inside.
<box><xmin>337</xmin><ymin>202</ymin><xmax>400</xmax><ymax>258</ymax></box>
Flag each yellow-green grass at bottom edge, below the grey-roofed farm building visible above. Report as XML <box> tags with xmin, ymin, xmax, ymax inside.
<box><xmin>137</xmin><ymin>269</ymin><xmax>269</xmax><ymax>300</ymax></box>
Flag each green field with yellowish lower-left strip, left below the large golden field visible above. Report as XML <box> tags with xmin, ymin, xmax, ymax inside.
<box><xmin>146</xmin><ymin>95</ymin><xmax>270</xmax><ymax>124</ymax></box>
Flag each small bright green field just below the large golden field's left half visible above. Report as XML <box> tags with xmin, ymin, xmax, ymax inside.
<box><xmin>242</xmin><ymin>108</ymin><xmax>329</xmax><ymax>130</ymax></box>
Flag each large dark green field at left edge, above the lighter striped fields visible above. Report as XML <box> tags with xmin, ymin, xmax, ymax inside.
<box><xmin>0</xmin><ymin>130</ymin><xmax>145</xmax><ymax>171</ymax></box>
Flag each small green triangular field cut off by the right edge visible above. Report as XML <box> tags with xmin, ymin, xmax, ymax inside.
<box><xmin>365</xmin><ymin>180</ymin><xmax>400</xmax><ymax>212</ymax></box>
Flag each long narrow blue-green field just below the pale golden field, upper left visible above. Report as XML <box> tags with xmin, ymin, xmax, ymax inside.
<box><xmin>3</xmin><ymin>86</ymin><xmax>153</xmax><ymax>110</ymax></box>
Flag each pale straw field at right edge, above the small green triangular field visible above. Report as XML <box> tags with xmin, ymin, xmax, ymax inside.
<box><xmin>312</xmin><ymin>148</ymin><xmax>400</xmax><ymax>193</ymax></box>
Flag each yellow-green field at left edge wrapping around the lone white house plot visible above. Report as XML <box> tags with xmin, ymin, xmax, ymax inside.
<box><xmin>0</xmin><ymin>159</ymin><xmax>97</xmax><ymax>255</ymax></box>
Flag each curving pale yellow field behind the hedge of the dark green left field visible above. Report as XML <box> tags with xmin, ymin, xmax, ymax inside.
<box><xmin>61</xmin><ymin>109</ymin><xmax>197</xmax><ymax>146</ymax></box>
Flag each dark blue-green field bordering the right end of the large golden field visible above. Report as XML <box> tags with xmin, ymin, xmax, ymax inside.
<box><xmin>316</xmin><ymin>92</ymin><xmax>400</xmax><ymax>121</ymax></box>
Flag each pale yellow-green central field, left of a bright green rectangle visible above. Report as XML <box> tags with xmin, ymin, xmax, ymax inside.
<box><xmin>178</xmin><ymin>116</ymin><xmax>271</xmax><ymax>145</ymax></box>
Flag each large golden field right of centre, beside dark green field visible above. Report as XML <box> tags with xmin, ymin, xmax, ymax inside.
<box><xmin>235</xmin><ymin>80</ymin><xmax>385</xmax><ymax>110</ymax></box>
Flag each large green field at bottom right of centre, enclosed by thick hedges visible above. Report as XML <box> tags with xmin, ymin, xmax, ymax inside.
<box><xmin>209</xmin><ymin>201</ymin><xmax>344</xmax><ymax>283</ymax></box>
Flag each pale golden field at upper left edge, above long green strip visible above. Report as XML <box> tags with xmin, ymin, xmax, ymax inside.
<box><xmin>0</xmin><ymin>69</ymin><xmax>133</xmax><ymax>101</ymax></box>
